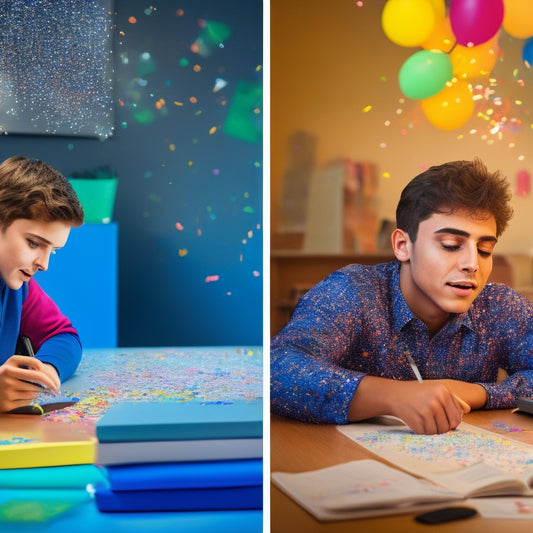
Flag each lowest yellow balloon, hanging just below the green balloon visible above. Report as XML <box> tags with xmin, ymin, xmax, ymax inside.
<box><xmin>422</xmin><ymin>80</ymin><xmax>474</xmax><ymax>130</ymax></box>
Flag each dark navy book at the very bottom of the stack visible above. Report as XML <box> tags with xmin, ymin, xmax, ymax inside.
<box><xmin>95</xmin><ymin>484</ymin><xmax>263</xmax><ymax>512</ymax></box>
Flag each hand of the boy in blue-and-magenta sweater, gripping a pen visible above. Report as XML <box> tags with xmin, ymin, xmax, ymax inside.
<box><xmin>0</xmin><ymin>355</ymin><xmax>60</xmax><ymax>413</ymax></box>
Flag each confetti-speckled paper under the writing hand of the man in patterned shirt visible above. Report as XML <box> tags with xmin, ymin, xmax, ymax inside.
<box><xmin>338</xmin><ymin>421</ymin><xmax>533</xmax><ymax>475</ymax></box>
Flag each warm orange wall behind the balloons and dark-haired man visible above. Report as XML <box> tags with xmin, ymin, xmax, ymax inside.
<box><xmin>270</xmin><ymin>0</ymin><xmax>533</xmax><ymax>255</ymax></box>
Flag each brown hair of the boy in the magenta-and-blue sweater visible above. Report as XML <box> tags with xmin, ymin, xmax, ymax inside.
<box><xmin>0</xmin><ymin>155</ymin><xmax>83</xmax><ymax>231</ymax></box>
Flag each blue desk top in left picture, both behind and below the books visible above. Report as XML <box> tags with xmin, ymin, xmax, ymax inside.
<box><xmin>0</xmin><ymin>346</ymin><xmax>263</xmax><ymax>533</ymax></box>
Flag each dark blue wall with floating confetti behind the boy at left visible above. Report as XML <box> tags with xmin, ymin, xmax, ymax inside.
<box><xmin>0</xmin><ymin>0</ymin><xmax>263</xmax><ymax>346</ymax></box>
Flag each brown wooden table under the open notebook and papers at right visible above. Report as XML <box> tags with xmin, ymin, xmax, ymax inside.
<box><xmin>270</xmin><ymin>410</ymin><xmax>533</xmax><ymax>533</ymax></box>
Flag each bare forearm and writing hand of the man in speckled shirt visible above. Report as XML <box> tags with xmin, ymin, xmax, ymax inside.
<box><xmin>348</xmin><ymin>376</ymin><xmax>469</xmax><ymax>435</ymax></box>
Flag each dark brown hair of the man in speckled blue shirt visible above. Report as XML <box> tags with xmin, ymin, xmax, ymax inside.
<box><xmin>396</xmin><ymin>158</ymin><xmax>513</xmax><ymax>242</ymax></box>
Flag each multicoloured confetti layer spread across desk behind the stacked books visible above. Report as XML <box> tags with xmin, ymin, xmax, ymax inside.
<box><xmin>45</xmin><ymin>347</ymin><xmax>263</xmax><ymax>423</ymax></box>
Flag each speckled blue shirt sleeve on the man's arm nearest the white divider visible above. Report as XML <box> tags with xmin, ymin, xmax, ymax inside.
<box><xmin>270</xmin><ymin>272</ymin><xmax>365</xmax><ymax>424</ymax></box>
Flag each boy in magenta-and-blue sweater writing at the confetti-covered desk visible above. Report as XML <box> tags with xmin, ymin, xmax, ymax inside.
<box><xmin>0</xmin><ymin>156</ymin><xmax>83</xmax><ymax>412</ymax></box>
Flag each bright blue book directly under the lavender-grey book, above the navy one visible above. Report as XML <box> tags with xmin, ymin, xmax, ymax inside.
<box><xmin>105</xmin><ymin>459</ymin><xmax>263</xmax><ymax>491</ymax></box>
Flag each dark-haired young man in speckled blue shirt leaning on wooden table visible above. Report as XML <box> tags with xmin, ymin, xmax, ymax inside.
<box><xmin>271</xmin><ymin>159</ymin><xmax>533</xmax><ymax>434</ymax></box>
